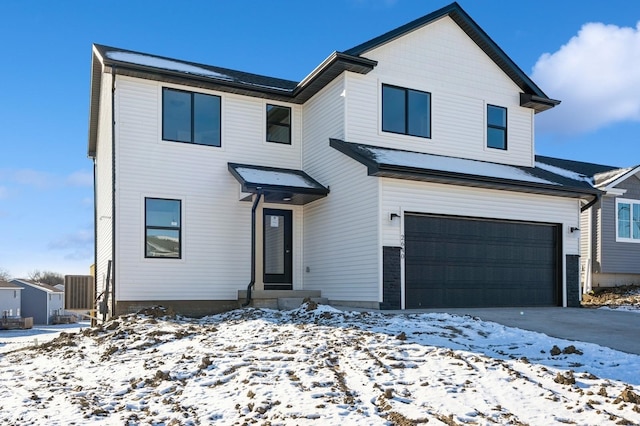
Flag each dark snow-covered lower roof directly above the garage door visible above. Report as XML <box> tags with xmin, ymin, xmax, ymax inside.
<box><xmin>330</xmin><ymin>139</ymin><xmax>600</xmax><ymax>198</ymax></box>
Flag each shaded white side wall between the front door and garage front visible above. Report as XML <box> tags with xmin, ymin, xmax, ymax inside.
<box><xmin>303</xmin><ymin>77</ymin><xmax>381</xmax><ymax>302</ymax></box>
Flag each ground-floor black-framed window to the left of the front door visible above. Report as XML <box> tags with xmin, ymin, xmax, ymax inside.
<box><xmin>144</xmin><ymin>198</ymin><xmax>182</xmax><ymax>259</ymax></box>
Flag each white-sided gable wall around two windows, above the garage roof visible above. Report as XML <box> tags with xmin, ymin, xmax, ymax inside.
<box><xmin>346</xmin><ymin>17</ymin><xmax>534</xmax><ymax>166</ymax></box>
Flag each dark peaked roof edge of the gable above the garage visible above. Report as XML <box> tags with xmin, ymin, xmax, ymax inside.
<box><xmin>344</xmin><ymin>2</ymin><xmax>560</xmax><ymax>112</ymax></box>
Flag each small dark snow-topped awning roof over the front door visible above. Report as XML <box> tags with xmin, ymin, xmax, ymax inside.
<box><xmin>228</xmin><ymin>163</ymin><xmax>329</xmax><ymax>205</ymax></box>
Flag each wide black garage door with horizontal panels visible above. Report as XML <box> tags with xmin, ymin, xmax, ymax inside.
<box><xmin>405</xmin><ymin>215</ymin><xmax>560</xmax><ymax>308</ymax></box>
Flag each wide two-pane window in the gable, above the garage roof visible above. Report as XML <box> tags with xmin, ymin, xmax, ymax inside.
<box><xmin>382</xmin><ymin>84</ymin><xmax>431</xmax><ymax>138</ymax></box>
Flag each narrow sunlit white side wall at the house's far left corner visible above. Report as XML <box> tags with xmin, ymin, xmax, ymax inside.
<box><xmin>95</xmin><ymin>74</ymin><xmax>113</xmax><ymax>306</ymax></box>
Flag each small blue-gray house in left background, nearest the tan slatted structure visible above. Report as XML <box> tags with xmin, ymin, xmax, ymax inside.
<box><xmin>11</xmin><ymin>278</ymin><xmax>64</xmax><ymax>325</ymax></box>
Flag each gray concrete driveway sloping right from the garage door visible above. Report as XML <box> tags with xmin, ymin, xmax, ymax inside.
<box><xmin>416</xmin><ymin>307</ymin><xmax>640</xmax><ymax>355</ymax></box>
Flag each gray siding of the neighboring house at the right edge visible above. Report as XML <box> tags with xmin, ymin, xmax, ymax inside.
<box><xmin>597</xmin><ymin>176</ymin><xmax>640</xmax><ymax>274</ymax></box>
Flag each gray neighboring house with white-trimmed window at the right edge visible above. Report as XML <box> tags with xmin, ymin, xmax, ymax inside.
<box><xmin>536</xmin><ymin>156</ymin><xmax>640</xmax><ymax>291</ymax></box>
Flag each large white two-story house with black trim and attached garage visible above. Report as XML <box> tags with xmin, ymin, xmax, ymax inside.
<box><xmin>88</xmin><ymin>3</ymin><xmax>600</xmax><ymax>315</ymax></box>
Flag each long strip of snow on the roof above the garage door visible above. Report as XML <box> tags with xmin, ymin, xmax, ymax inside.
<box><xmin>366</xmin><ymin>147</ymin><xmax>559</xmax><ymax>185</ymax></box>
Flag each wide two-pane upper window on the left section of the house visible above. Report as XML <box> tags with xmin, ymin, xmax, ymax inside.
<box><xmin>162</xmin><ymin>87</ymin><xmax>221</xmax><ymax>146</ymax></box>
